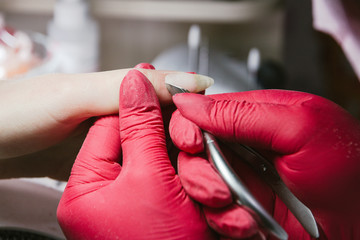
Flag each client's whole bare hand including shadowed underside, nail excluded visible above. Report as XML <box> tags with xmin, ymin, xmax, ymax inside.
<box><xmin>0</xmin><ymin>69</ymin><xmax>212</xmax><ymax>179</ymax></box>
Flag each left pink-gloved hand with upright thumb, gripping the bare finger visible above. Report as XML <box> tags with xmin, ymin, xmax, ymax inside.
<box><xmin>58</xmin><ymin>70</ymin><xmax>214</xmax><ymax>240</ymax></box>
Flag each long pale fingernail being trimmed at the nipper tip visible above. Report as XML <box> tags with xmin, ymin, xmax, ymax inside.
<box><xmin>165</xmin><ymin>73</ymin><xmax>214</xmax><ymax>92</ymax></box>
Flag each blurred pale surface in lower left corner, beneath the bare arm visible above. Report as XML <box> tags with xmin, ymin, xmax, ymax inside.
<box><xmin>0</xmin><ymin>179</ymin><xmax>64</xmax><ymax>238</ymax></box>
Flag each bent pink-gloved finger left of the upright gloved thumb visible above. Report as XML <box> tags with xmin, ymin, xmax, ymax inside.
<box><xmin>68</xmin><ymin>115</ymin><xmax>121</xmax><ymax>185</ymax></box>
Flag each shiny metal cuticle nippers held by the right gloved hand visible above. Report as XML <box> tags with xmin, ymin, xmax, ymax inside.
<box><xmin>166</xmin><ymin>83</ymin><xmax>319</xmax><ymax>240</ymax></box>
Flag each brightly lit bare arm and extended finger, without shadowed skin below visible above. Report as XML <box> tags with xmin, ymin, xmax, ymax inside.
<box><xmin>0</xmin><ymin>69</ymin><xmax>171</xmax><ymax>158</ymax></box>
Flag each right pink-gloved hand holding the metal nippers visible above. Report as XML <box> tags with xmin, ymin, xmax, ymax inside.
<box><xmin>170</xmin><ymin>90</ymin><xmax>360</xmax><ymax>240</ymax></box>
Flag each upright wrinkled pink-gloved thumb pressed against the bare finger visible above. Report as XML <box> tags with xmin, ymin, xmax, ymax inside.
<box><xmin>119</xmin><ymin>70</ymin><xmax>174</xmax><ymax>174</ymax></box>
